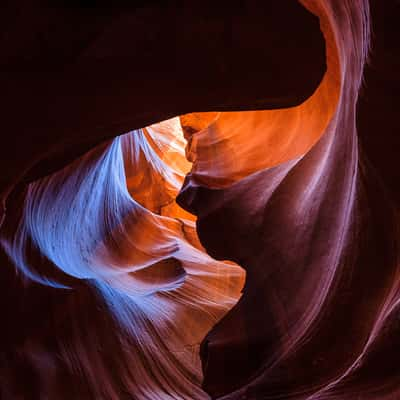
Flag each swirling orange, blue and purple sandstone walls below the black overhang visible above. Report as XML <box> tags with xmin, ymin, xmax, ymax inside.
<box><xmin>0</xmin><ymin>0</ymin><xmax>400</xmax><ymax>400</ymax></box>
